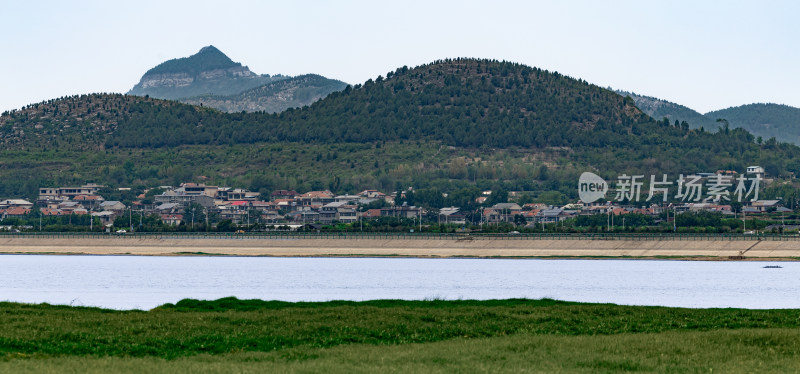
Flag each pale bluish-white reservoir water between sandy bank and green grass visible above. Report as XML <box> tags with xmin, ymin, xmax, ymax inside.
<box><xmin>0</xmin><ymin>255</ymin><xmax>800</xmax><ymax>309</ymax></box>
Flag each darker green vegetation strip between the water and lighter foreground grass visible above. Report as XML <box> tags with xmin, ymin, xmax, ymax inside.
<box><xmin>0</xmin><ymin>298</ymin><xmax>800</xmax><ymax>360</ymax></box>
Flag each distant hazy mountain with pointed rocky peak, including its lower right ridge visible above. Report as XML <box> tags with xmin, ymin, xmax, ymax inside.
<box><xmin>128</xmin><ymin>46</ymin><xmax>347</xmax><ymax>113</ymax></box>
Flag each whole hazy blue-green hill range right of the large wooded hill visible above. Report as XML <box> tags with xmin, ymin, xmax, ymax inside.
<box><xmin>617</xmin><ymin>90</ymin><xmax>800</xmax><ymax>145</ymax></box>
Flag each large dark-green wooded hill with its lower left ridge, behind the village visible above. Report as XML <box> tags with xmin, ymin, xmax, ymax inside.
<box><xmin>0</xmin><ymin>59</ymin><xmax>800</xmax><ymax>201</ymax></box>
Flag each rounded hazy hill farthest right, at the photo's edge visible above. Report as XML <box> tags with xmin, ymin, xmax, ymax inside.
<box><xmin>705</xmin><ymin>104</ymin><xmax>800</xmax><ymax>144</ymax></box>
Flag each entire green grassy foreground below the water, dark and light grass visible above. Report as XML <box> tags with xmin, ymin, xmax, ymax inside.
<box><xmin>0</xmin><ymin>299</ymin><xmax>800</xmax><ymax>373</ymax></box>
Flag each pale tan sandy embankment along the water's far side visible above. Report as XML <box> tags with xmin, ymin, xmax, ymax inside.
<box><xmin>0</xmin><ymin>237</ymin><xmax>800</xmax><ymax>259</ymax></box>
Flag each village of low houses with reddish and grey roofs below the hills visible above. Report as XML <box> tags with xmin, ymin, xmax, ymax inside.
<box><xmin>0</xmin><ymin>169</ymin><xmax>793</xmax><ymax>230</ymax></box>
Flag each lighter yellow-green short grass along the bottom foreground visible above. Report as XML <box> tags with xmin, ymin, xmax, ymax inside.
<box><xmin>6</xmin><ymin>329</ymin><xmax>800</xmax><ymax>373</ymax></box>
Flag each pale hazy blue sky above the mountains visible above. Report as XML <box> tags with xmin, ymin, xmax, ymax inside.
<box><xmin>0</xmin><ymin>0</ymin><xmax>800</xmax><ymax>112</ymax></box>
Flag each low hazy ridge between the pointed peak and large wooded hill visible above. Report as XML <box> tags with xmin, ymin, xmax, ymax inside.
<box><xmin>181</xmin><ymin>74</ymin><xmax>347</xmax><ymax>113</ymax></box>
